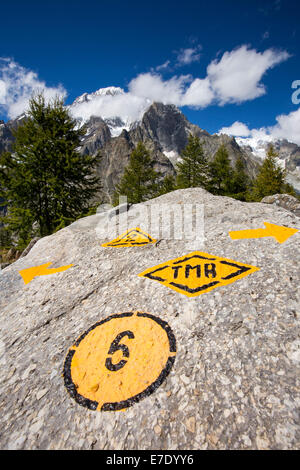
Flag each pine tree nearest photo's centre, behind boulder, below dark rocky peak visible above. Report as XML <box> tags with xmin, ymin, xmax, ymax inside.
<box><xmin>114</xmin><ymin>142</ymin><xmax>160</xmax><ymax>204</ymax></box>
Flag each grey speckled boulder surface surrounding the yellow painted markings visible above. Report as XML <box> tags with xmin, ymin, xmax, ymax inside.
<box><xmin>0</xmin><ymin>188</ymin><xmax>300</xmax><ymax>449</ymax></box>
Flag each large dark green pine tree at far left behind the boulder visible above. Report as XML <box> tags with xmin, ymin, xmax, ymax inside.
<box><xmin>0</xmin><ymin>94</ymin><xmax>100</xmax><ymax>250</ymax></box>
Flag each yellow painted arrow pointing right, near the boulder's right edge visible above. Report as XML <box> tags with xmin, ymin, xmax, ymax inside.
<box><xmin>229</xmin><ymin>222</ymin><xmax>298</xmax><ymax>243</ymax></box>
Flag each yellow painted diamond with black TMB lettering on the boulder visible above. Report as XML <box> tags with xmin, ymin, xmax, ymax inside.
<box><xmin>139</xmin><ymin>251</ymin><xmax>259</xmax><ymax>297</ymax></box>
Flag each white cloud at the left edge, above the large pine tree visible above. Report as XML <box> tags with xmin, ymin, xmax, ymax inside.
<box><xmin>0</xmin><ymin>58</ymin><xmax>66</xmax><ymax>119</ymax></box>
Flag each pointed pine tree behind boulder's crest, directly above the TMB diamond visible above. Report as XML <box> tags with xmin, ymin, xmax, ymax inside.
<box><xmin>176</xmin><ymin>135</ymin><xmax>208</xmax><ymax>188</ymax></box>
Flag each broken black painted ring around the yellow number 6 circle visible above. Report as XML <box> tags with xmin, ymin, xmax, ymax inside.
<box><xmin>63</xmin><ymin>312</ymin><xmax>176</xmax><ymax>411</ymax></box>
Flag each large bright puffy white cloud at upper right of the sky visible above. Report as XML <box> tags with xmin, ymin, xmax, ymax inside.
<box><xmin>207</xmin><ymin>46</ymin><xmax>290</xmax><ymax>105</ymax></box>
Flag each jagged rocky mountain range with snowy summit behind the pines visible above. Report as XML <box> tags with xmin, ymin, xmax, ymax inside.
<box><xmin>0</xmin><ymin>87</ymin><xmax>300</xmax><ymax>197</ymax></box>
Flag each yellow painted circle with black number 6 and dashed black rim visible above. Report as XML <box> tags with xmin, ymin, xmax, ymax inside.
<box><xmin>63</xmin><ymin>312</ymin><xmax>176</xmax><ymax>411</ymax></box>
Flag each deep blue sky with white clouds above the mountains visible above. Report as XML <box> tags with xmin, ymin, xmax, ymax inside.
<box><xmin>0</xmin><ymin>0</ymin><xmax>300</xmax><ymax>140</ymax></box>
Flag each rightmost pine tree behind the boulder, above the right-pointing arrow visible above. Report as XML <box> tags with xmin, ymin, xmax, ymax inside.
<box><xmin>253</xmin><ymin>145</ymin><xmax>286</xmax><ymax>201</ymax></box>
